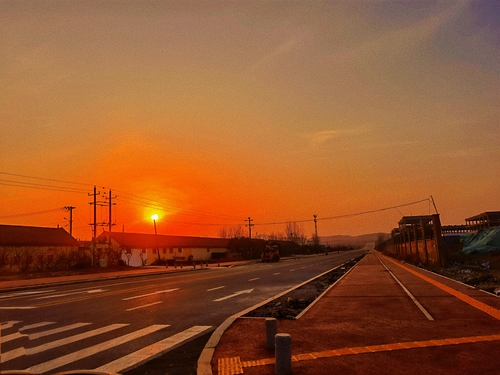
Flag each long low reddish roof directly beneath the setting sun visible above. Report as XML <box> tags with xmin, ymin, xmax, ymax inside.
<box><xmin>99</xmin><ymin>232</ymin><xmax>230</xmax><ymax>249</ymax></box>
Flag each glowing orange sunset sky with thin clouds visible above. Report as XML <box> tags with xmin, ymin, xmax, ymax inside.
<box><xmin>0</xmin><ymin>0</ymin><xmax>500</xmax><ymax>239</ymax></box>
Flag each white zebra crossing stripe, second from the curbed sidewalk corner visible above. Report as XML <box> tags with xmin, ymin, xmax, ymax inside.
<box><xmin>26</xmin><ymin>324</ymin><xmax>169</xmax><ymax>374</ymax></box>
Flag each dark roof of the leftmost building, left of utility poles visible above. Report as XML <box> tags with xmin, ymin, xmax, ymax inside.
<box><xmin>0</xmin><ymin>224</ymin><xmax>78</xmax><ymax>246</ymax></box>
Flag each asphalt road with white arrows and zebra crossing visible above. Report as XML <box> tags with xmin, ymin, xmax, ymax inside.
<box><xmin>0</xmin><ymin>250</ymin><xmax>365</xmax><ymax>374</ymax></box>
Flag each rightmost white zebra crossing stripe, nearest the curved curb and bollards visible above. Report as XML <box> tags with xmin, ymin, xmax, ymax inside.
<box><xmin>95</xmin><ymin>326</ymin><xmax>212</xmax><ymax>373</ymax></box>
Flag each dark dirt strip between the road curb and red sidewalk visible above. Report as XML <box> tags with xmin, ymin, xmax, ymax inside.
<box><xmin>245</xmin><ymin>255</ymin><xmax>364</xmax><ymax>319</ymax></box>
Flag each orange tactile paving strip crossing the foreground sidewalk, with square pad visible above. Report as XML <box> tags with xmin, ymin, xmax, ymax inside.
<box><xmin>217</xmin><ymin>334</ymin><xmax>500</xmax><ymax>375</ymax></box>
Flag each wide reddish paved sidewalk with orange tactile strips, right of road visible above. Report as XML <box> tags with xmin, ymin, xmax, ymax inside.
<box><xmin>202</xmin><ymin>252</ymin><xmax>500</xmax><ymax>375</ymax></box>
